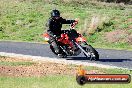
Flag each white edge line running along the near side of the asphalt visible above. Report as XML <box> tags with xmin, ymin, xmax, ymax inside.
<box><xmin>0</xmin><ymin>52</ymin><xmax>128</xmax><ymax>69</ymax></box>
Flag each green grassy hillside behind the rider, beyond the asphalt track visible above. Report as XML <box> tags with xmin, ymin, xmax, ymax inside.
<box><xmin>0</xmin><ymin>0</ymin><xmax>132</xmax><ymax>49</ymax></box>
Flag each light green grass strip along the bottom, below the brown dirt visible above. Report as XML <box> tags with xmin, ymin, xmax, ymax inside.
<box><xmin>0</xmin><ymin>76</ymin><xmax>132</xmax><ymax>88</ymax></box>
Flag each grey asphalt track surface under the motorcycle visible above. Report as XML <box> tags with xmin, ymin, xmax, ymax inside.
<box><xmin>0</xmin><ymin>41</ymin><xmax>132</xmax><ymax>69</ymax></box>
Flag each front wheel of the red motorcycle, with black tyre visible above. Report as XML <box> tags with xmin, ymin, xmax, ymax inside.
<box><xmin>84</xmin><ymin>45</ymin><xmax>99</xmax><ymax>61</ymax></box>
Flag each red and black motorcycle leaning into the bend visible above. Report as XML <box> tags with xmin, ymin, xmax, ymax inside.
<box><xmin>43</xmin><ymin>22</ymin><xmax>99</xmax><ymax>60</ymax></box>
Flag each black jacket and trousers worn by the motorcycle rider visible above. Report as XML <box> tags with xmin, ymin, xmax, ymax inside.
<box><xmin>47</xmin><ymin>17</ymin><xmax>75</xmax><ymax>54</ymax></box>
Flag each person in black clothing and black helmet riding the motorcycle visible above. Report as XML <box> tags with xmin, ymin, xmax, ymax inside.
<box><xmin>47</xmin><ymin>9</ymin><xmax>77</xmax><ymax>57</ymax></box>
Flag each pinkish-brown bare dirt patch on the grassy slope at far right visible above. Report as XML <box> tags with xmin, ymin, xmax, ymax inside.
<box><xmin>105</xmin><ymin>30</ymin><xmax>132</xmax><ymax>44</ymax></box>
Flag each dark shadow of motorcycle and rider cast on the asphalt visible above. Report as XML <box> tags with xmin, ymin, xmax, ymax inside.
<box><xmin>66</xmin><ymin>57</ymin><xmax>132</xmax><ymax>62</ymax></box>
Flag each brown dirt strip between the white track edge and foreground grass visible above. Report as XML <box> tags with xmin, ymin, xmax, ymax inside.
<box><xmin>0</xmin><ymin>57</ymin><xmax>104</xmax><ymax>77</ymax></box>
